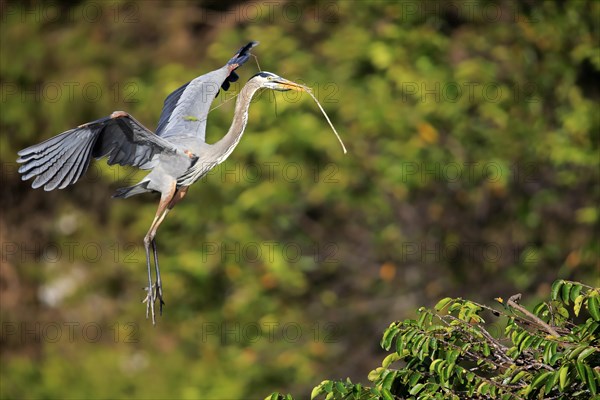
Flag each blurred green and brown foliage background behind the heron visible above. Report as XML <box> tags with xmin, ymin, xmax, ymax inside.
<box><xmin>0</xmin><ymin>1</ymin><xmax>600</xmax><ymax>398</ymax></box>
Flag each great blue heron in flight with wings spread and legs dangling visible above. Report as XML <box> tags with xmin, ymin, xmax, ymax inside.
<box><xmin>17</xmin><ymin>42</ymin><xmax>305</xmax><ymax>324</ymax></box>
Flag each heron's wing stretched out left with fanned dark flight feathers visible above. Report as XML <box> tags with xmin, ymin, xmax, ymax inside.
<box><xmin>17</xmin><ymin>111</ymin><xmax>176</xmax><ymax>191</ymax></box>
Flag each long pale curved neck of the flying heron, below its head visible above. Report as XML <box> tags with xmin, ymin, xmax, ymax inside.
<box><xmin>214</xmin><ymin>81</ymin><xmax>259</xmax><ymax>164</ymax></box>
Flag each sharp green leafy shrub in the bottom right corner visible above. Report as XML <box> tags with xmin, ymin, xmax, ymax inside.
<box><xmin>270</xmin><ymin>280</ymin><xmax>600</xmax><ymax>400</ymax></box>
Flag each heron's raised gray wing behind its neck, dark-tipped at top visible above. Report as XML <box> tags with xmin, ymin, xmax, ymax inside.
<box><xmin>156</xmin><ymin>42</ymin><xmax>258</xmax><ymax>141</ymax></box>
